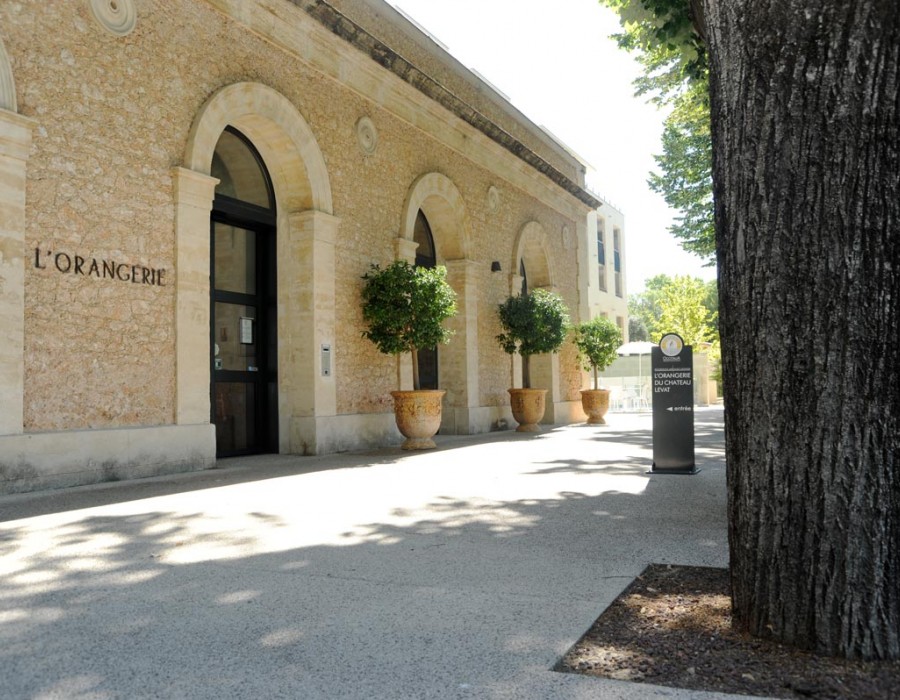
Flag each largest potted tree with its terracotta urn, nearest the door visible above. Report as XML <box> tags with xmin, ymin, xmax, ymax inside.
<box><xmin>362</xmin><ymin>260</ymin><xmax>456</xmax><ymax>450</ymax></box>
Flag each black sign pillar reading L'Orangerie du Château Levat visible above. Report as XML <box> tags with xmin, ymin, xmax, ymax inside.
<box><xmin>650</xmin><ymin>333</ymin><xmax>699</xmax><ymax>474</ymax></box>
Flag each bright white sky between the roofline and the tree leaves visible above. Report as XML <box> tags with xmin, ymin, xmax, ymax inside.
<box><xmin>388</xmin><ymin>0</ymin><xmax>715</xmax><ymax>294</ymax></box>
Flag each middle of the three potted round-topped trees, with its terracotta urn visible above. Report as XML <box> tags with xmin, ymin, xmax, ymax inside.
<box><xmin>497</xmin><ymin>289</ymin><xmax>569</xmax><ymax>432</ymax></box>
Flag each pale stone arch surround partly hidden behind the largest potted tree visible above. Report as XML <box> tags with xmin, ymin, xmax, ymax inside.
<box><xmin>398</xmin><ymin>172</ymin><xmax>478</xmax><ymax>434</ymax></box>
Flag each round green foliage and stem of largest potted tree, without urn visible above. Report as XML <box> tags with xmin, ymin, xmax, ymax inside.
<box><xmin>362</xmin><ymin>260</ymin><xmax>456</xmax><ymax>389</ymax></box>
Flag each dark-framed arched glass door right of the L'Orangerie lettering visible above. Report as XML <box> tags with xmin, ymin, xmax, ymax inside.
<box><xmin>210</xmin><ymin>127</ymin><xmax>278</xmax><ymax>457</ymax></box>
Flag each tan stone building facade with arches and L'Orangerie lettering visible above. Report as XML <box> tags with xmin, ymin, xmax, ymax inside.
<box><xmin>0</xmin><ymin>0</ymin><xmax>624</xmax><ymax>492</ymax></box>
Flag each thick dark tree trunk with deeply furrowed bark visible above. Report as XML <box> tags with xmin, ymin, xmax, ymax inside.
<box><xmin>704</xmin><ymin>0</ymin><xmax>900</xmax><ymax>659</ymax></box>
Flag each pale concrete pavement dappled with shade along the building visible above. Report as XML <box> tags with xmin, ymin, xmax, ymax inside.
<box><xmin>0</xmin><ymin>408</ymin><xmax>752</xmax><ymax>699</ymax></box>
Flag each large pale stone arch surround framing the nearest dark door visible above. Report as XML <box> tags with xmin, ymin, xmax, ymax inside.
<box><xmin>174</xmin><ymin>83</ymin><xmax>339</xmax><ymax>454</ymax></box>
